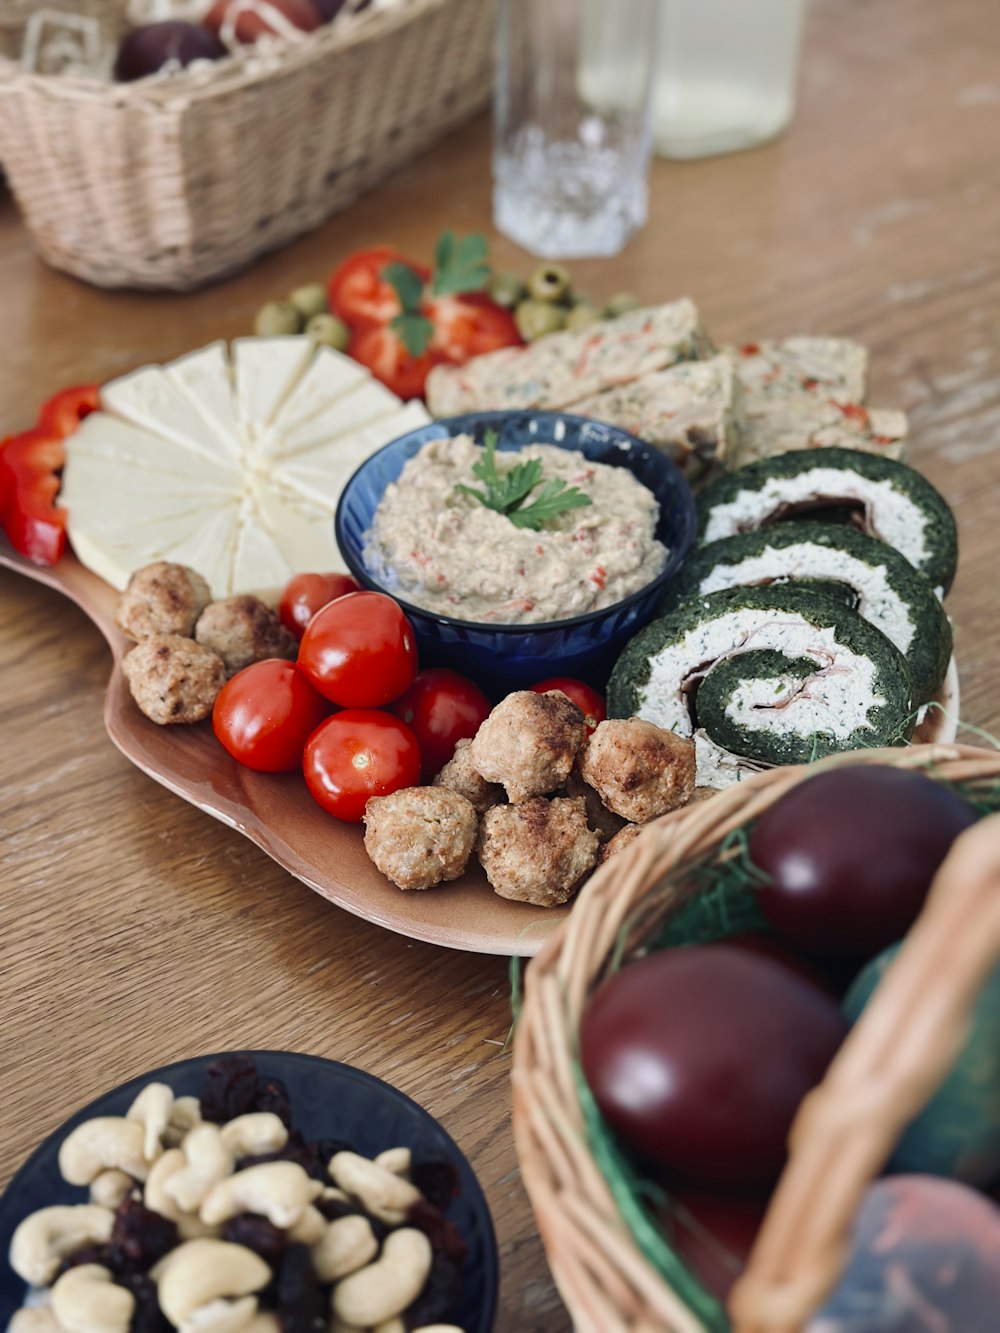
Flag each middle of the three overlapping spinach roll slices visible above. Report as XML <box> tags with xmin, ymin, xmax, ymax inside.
<box><xmin>663</xmin><ymin>520</ymin><xmax>952</xmax><ymax>704</ymax></box>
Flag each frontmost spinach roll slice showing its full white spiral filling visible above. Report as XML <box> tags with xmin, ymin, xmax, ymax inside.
<box><xmin>608</xmin><ymin>584</ymin><xmax>915</xmax><ymax>786</ymax></box>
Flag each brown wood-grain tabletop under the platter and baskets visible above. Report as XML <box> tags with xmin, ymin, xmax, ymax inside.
<box><xmin>0</xmin><ymin>0</ymin><xmax>1000</xmax><ymax>1333</ymax></box>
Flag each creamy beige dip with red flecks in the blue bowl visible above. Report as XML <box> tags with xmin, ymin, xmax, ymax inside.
<box><xmin>364</xmin><ymin>435</ymin><xmax>667</xmax><ymax>624</ymax></box>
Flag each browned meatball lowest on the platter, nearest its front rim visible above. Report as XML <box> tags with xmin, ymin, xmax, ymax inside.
<box><xmin>477</xmin><ymin>796</ymin><xmax>600</xmax><ymax>908</ymax></box>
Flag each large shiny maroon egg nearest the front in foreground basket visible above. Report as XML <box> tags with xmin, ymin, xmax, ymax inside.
<box><xmin>580</xmin><ymin>944</ymin><xmax>847</xmax><ymax>1189</ymax></box>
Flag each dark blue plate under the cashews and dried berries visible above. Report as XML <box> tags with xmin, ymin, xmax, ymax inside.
<box><xmin>0</xmin><ymin>1050</ymin><xmax>497</xmax><ymax>1333</ymax></box>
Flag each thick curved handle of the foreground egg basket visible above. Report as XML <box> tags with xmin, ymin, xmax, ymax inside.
<box><xmin>729</xmin><ymin>814</ymin><xmax>1000</xmax><ymax>1333</ymax></box>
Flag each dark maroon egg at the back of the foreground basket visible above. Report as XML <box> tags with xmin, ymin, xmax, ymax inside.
<box><xmin>749</xmin><ymin>764</ymin><xmax>976</xmax><ymax>958</ymax></box>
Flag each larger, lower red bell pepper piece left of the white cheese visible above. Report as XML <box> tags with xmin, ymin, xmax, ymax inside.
<box><xmin>0</xmin><ymin>429</ymin><xmax>67</xmax><ymax>565</ymax></box>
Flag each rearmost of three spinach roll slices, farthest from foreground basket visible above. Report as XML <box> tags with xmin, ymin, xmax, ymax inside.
<box><xmin>697</xmin><ymin>448</ymin><xmax>959</xmax><ymax>595</ymax></box>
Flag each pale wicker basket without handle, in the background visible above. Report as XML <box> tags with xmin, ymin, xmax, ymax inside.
<box><xmin>0</xmin><ymin>0</ymin><xmax>492</xmax><ymax>291</ymax></box>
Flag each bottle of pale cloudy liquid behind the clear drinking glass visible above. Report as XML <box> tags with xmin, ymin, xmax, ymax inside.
<box><xmin>652</xmin><ymin>0</ymin><xmax>804</xmax><ymax>157</ymax></box>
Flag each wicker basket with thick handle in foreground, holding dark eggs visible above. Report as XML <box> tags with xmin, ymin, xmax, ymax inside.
<box><xmin>512</xmin><ymin>745</ymin><xmax>1000</xmax><ymax>1333</ymax></box>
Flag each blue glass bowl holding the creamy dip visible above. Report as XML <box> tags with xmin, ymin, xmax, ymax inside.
<box><xmin>333</xmin><ymin>412</ymin><xmax>697</xmax><ymax>694</ymax></box>
